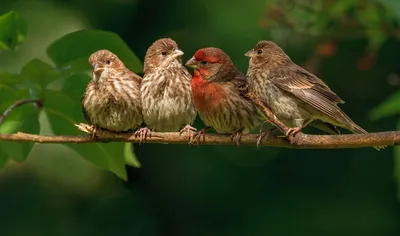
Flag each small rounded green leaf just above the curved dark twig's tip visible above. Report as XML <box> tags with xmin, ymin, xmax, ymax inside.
<box><xmin>21</xmin><ymin>59</ymin><xmax>61</xmax><ymax>89</ymax></box>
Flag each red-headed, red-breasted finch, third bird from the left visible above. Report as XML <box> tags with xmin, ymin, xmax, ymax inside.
<box><xmin>186</xmin><ymin>48</ymin><xmax>263</xmax><ymax>145</ymax></box>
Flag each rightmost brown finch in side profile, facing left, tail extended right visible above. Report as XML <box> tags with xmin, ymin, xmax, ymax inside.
<box><xmin>245</xmin><ymin>41</ymin><xmax>382</xmax><ymax>148</ymax></box>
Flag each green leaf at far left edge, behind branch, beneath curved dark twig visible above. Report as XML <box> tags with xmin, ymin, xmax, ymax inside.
<box><xmin>0</xmin><ymin>104</ymin><xmax>40</xmax><ymax>161</ymax></box>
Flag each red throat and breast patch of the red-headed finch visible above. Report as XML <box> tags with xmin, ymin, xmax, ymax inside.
<box><xmin>192</xmin><ymin>70</ymin><xmax>225</xmax><ymax>112</ymax></box>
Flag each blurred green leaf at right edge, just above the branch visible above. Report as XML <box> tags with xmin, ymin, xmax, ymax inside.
<box><xmin>369</xmin><ymin>92</ymin><xmax>400</xmax><ymax>120</ymax></box>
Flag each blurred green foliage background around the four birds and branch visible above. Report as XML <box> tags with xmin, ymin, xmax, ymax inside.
<box><xmin>0</xmin><ymin>0</ymin><xmax>400</xmax><ymax>236</ymax></box>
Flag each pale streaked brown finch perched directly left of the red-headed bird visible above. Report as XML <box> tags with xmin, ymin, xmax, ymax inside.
<box><xmin>140</xmin><ymin>38</ymin><xmax>196</xmax><ymax>139</ymax></box>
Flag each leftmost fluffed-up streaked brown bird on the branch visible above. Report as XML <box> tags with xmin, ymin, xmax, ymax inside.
<box><xmin>81</xmin><ymin>50</ymin><xmax>143</xmax><ymax>136</ymax></box>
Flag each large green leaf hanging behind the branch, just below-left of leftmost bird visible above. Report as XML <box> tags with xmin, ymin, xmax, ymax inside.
<box><xmin>44</xmin><ymin>90</ymin><xmax>127</xmax><ymax>180</ymax></box>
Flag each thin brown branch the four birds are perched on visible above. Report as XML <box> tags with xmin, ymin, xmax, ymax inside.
<box><xmin>0</xmin><ymin>124</ymin><xmax>400</xmax><ymax>149</ymax></box>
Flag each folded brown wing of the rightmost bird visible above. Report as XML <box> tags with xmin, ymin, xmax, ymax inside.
<box><xmin>269</xmin><ymin>65</ymin><xmax>355</xmax><ymax>126</ymax></box>
